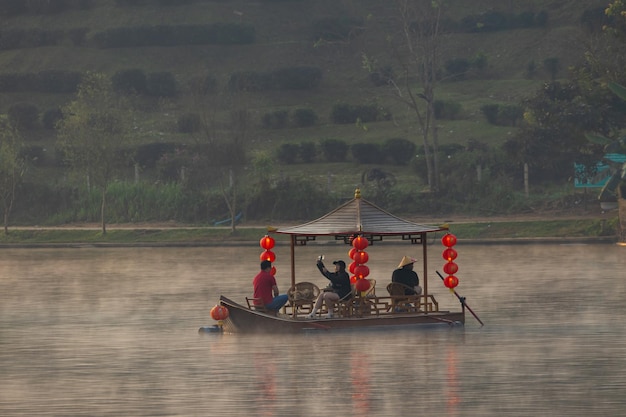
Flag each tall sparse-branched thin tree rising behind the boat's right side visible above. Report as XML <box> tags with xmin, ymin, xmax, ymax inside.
<box><xmin>363</xmin><ymin>0</ymin><xmax>445</xmax><ymax>192</ymax></box>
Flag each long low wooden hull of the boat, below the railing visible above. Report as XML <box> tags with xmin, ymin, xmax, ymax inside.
<box><xmin>220</xmin><ymin>296</ymin><xmax>465</xmax><ymax>333</ymax></box>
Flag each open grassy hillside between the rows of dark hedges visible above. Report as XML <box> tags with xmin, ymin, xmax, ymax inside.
<box><xmin>0</xmin><ymin>0</ymin><xmax>606</xmax><ymax>216</ymax></box>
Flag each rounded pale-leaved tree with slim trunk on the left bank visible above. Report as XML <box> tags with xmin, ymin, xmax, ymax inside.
<box><xmin>57</xmin><ymin>73</ymin><xmax>133</xmax><ymax>234</ymax></box>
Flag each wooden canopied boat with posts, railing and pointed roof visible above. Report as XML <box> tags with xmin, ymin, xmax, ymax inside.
<box><xmin>207</xmin><ymin>189</ymin><xmax>482</xmax><ymax>333</ymax></box>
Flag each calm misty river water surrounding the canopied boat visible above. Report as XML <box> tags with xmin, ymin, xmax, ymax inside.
<box><xmin>0</xmin><ymin>242</ymin><xmax>626</xmax><ymax>417</ymax></box>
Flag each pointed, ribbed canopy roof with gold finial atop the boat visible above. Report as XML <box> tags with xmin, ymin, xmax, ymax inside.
<box><xmin>271</xmin><ymin>189</ymin><xmax>447</xmax><ymax>241</ymax></box>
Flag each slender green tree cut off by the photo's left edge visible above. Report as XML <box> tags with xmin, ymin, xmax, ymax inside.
<box><xmin>0</xmin><ymin>120</ymin><xmax>26</xmax><ymax>234</ymax></box>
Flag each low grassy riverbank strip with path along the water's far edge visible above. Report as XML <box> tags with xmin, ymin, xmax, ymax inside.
<box><xmin>0</xmin><ymin>213</ymin><xmax>617</xmax><ymax>248</ymax></box>
